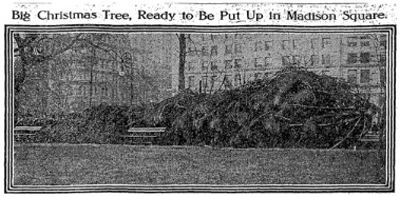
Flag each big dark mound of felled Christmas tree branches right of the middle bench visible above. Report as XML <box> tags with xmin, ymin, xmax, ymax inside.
<box><xmin>139</xmin><ymin>68</ymin><xmax>375</xmax><ymax>148</ymax></box>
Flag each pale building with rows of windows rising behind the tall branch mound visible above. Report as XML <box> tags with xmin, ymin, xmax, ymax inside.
<box><xmin>175</xmin><ymin>33</ymin><xmax>387</xmax><ymax>106</ymax></box>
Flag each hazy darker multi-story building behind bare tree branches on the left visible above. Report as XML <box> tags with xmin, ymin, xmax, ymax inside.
<box><xmin>14</xmin><ymin>34</ymin><xmax>176</xmax><ymax>114</ymax></box>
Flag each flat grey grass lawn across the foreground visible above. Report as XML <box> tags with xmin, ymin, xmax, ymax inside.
<box><xmin>14</xmin><ymin>144</ymin><xmax>385</xmax><ymax>185</ymax></box>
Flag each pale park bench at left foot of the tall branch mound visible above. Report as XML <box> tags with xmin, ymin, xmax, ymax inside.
<box><xmin>120</xmin><ymin>127</ymin><xmax>166</xmax><ymax>144</ymax></box>
